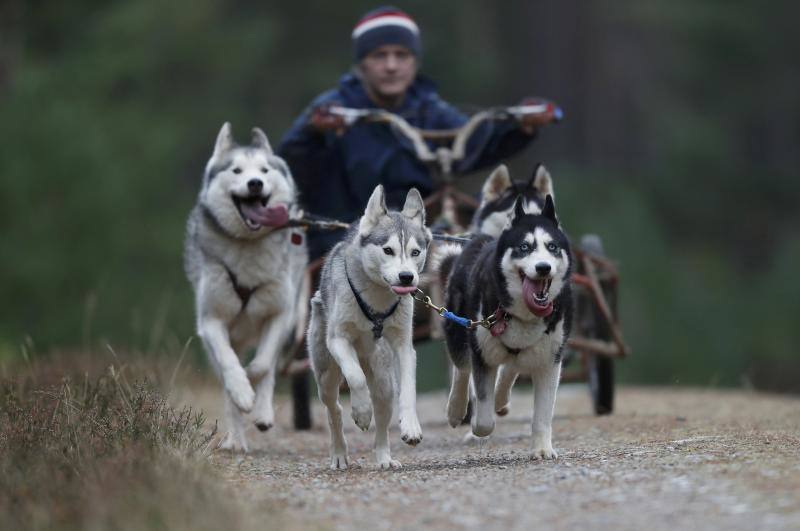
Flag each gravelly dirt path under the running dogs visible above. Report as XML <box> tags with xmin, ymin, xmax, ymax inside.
<box><xmin>184</xmin><ymin>385</ymin><xmax>800</xmax><ymax>531</ymax></box>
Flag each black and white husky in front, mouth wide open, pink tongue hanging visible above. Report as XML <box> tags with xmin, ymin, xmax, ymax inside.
<box><xmin>437</xmin><ymin>195</ymin><xmax>572</xmax><ymax>459</ymax></box>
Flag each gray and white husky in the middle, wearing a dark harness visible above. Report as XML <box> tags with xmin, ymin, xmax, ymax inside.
<box><xmin>308</xmin><ymin>186</ymin><xmax>431</xmax><ymax>470</ymax></box>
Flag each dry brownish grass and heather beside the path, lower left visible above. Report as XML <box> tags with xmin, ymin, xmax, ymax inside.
<box><xmin>0</xmin><ymin>356</ymin><xmax>268</xmax><ymax>529</ymax></box>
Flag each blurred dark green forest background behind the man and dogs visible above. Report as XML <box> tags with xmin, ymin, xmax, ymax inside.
<box><xmin>0</xmin><ymin>0</ymin><xmax>800</xmax><ymax>391</ymax></box>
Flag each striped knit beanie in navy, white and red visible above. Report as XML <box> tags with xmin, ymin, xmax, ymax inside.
<box><xmin>353</xmin><ymin>6</ymin><xmax>422</xmax><ymax>62</ymax></box>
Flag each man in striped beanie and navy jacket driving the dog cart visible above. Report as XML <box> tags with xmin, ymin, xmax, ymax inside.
<box><xmin>278</xmin><ymin>7</ymin><xmax>536</xmax><ymax>260</ymax></box>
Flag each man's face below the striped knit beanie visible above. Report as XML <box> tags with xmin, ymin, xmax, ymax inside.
<box><xmin>361</xmin><ymin>44</ymin><xmax>417</xmax><ymax>105</ymax></box>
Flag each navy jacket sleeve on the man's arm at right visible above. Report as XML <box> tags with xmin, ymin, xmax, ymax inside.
<box><xmin>424</xmin><ymin>98</ymin><xmax>536</xmax><ymax>173</ymax></box>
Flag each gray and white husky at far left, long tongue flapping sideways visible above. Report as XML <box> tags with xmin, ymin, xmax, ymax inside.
<box><xmin>184</xmin><ymin>123</ymin><xmax>308</xmax><ymax>452</ymax></box>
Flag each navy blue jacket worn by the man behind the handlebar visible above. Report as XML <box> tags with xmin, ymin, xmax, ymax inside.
<box><xmin>278</xmin><ymin>74</ymin><xmax>533</xmax><ymax>259</ymax></box>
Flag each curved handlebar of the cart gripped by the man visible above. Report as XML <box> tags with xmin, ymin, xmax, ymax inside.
<box><xmin>311</xmin><ymin>101</ymin><xmax>564</xmax><ymax>173</ymax></box>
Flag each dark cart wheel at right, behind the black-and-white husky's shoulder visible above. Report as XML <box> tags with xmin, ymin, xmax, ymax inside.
<box><xmin>577</xmin><ymin>234</ymin><xmax>616</xmax><ymax>415</ymax></box>
